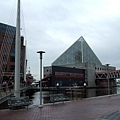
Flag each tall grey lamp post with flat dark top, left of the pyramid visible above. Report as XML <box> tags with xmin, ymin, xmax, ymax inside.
<box><xmin>37</xmin><ymin>51</ymin><xmax>45</xmax><ymax>107</ymax></box>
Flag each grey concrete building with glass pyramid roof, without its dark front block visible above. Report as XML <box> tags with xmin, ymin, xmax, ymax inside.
<box><xmin>44</xmin><ymin>37</ymin><xmax>116</xmax><ymax>87</ymax></box>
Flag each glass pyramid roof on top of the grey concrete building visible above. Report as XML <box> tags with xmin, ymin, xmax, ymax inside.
<box><xmin>52</xmin><ymin>36</ymin><xmax>102</xmax><ymax>66</ymax></box>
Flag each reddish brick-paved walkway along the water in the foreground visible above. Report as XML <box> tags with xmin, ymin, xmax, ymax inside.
<box><xmin>0</xmin><ymin>95</ymin><xmax>120</xmax><ymax>120</ymax></box>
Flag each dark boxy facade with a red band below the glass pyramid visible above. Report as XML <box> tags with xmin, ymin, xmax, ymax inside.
<box><xmin>51</xmin><ymin>66</ymin><xmax>85</xmax><ymax>87</ymax></box>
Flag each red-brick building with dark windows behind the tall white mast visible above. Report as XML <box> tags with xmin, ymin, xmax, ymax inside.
<box><xmin>0</xmin><ymin>23</ymin><xmax>25</xmax><ymax>82</ymax></box>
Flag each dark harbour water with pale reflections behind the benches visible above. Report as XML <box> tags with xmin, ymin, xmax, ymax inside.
<box><xmin>0</xmin><ymin>87</ymin><xmax>120</xmax><ymax>109</ymax></box>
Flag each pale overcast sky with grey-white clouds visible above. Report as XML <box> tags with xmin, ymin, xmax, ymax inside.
<box><xmin>0</xmin><ymin>0</ymin><xmax>120</xmax><ymax>78</ymax></box>
